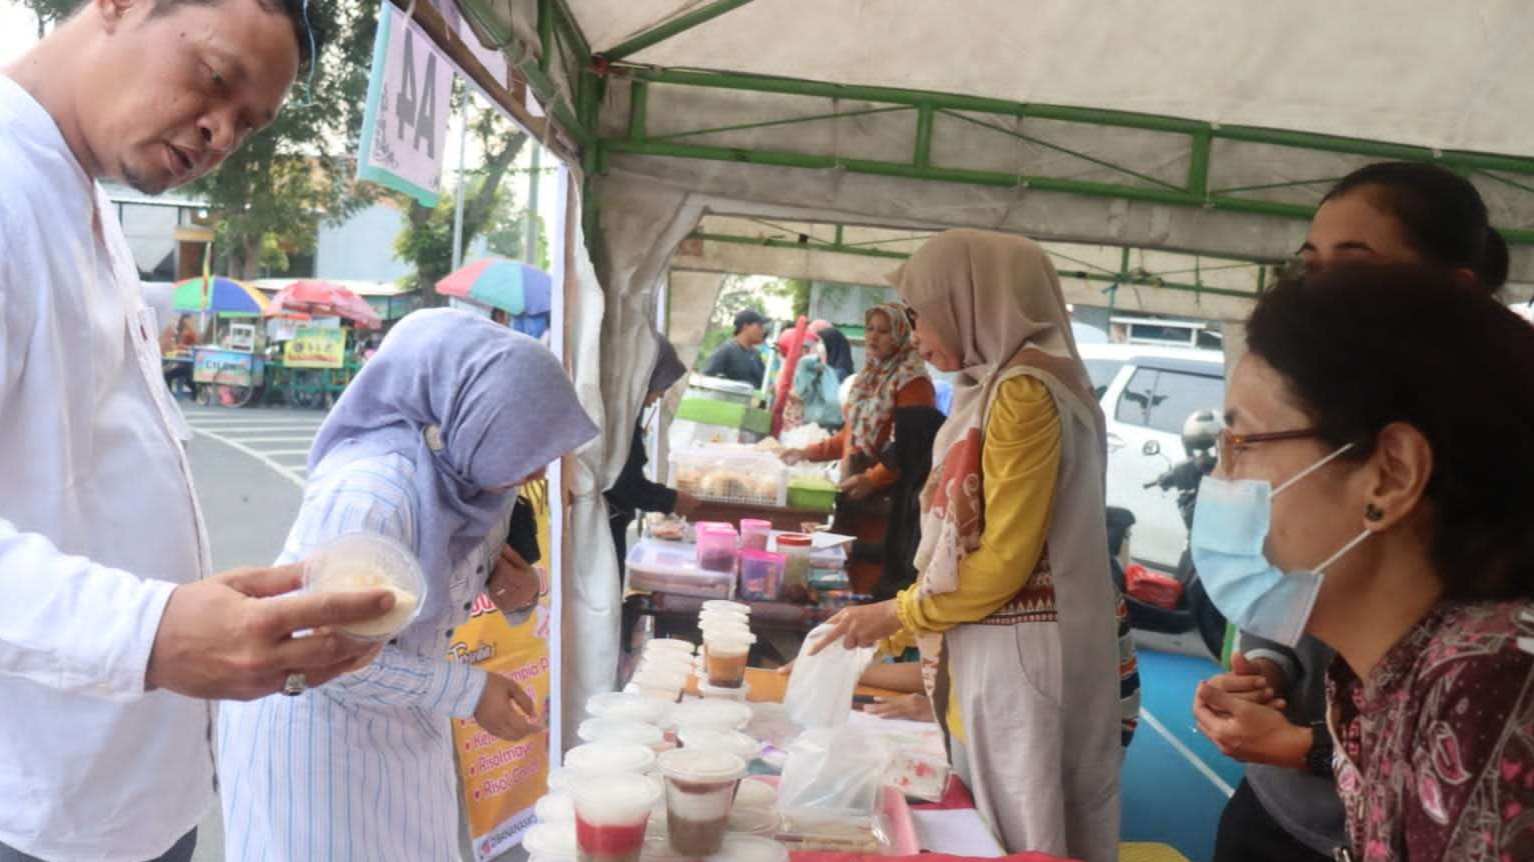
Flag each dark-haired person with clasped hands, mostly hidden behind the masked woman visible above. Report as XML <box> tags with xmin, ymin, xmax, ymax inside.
<box><xmin>1193</xmin><ymin>163</ymin><xmax>1508</xmax><ymax>862</ymax></box>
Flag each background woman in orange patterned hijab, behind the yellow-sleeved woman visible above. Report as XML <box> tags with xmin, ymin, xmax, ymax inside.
<box><xmin>782</xmin><ymin>302</ymin><xmax>933</xmax><ymax>594</ymax></box>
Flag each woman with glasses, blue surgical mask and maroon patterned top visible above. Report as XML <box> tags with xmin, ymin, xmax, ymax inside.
<box><xmin>1192</xmin><ymin>267</ymin><xmax>1534</xmax><ymax>862</ymax></box>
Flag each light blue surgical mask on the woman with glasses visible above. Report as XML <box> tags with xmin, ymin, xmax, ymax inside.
<box><xmin>1189</xmin><ymin>443</ymin><xmax>1370</xmax><ymax>647</ymax></box>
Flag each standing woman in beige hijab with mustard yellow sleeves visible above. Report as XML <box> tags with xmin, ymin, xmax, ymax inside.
<box><xmin>822</xmin><ymin>230</ymin><xmax>1121</xmax><ymax>862</ymax></box>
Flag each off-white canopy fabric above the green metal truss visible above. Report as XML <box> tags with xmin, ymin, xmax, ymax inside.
<box><xmin>569</xmin><ymin>0</ymin><xmax>1534</xmax><ymax>155</ymax></box>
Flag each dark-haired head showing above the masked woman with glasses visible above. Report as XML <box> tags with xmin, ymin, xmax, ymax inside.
<box><xmin>1301</xmin><ymin>161</ymin><xmax>1508</xmax><ymax>293</ymax></box>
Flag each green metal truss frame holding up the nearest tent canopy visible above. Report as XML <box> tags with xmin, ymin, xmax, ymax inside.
<box><xmin>468</xmin><ymin>0</ymin><xmax>1534</xmax><ymax>266</ymax></box>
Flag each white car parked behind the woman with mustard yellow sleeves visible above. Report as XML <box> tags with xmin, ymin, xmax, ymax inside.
<box><xmin>1078</xmin><ymin>344</ymin><xmax>1226</xmax><ymax>574</ymax></box>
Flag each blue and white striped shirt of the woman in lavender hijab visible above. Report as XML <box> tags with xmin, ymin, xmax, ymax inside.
<box><xmin>218</xmin><ymin>456</ymin><xmax>511</xmax><ymax>862</ymax></box>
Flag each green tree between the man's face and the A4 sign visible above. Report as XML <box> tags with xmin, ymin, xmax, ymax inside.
<box><xmin>23</xmin><ymin>0</ymin><xmax>377</xmax><ymax>278</ymax></box>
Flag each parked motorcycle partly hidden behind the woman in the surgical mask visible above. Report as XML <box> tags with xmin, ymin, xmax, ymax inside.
<box><xmin>1108</xmin><ymin>411</ymin><xmax>1226</xmax><ymax>656</ymax></box>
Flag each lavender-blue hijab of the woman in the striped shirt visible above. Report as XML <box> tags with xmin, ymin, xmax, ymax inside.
<box><xmin>308</xmin><ymin>308</ymin><xmax>597</xmax><ymax>618</ymax></box>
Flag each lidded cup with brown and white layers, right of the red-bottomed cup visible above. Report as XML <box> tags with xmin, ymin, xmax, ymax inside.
<box><xmin>658</xmin><ymin>748</ymin><xmax>746</xmax><ymax>856</ymax></box>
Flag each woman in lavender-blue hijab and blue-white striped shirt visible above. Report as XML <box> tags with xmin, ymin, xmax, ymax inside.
<box><xmin>218</xmin><ymin>308</ymin><xmax>597</xmax><ymax>862</ymax></box>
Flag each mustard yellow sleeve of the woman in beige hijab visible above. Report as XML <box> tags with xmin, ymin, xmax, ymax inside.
<box><xmin>896</xmin><ymin>376</ymin><xmax>1060</xmax><ymax>632</ymax></box>
